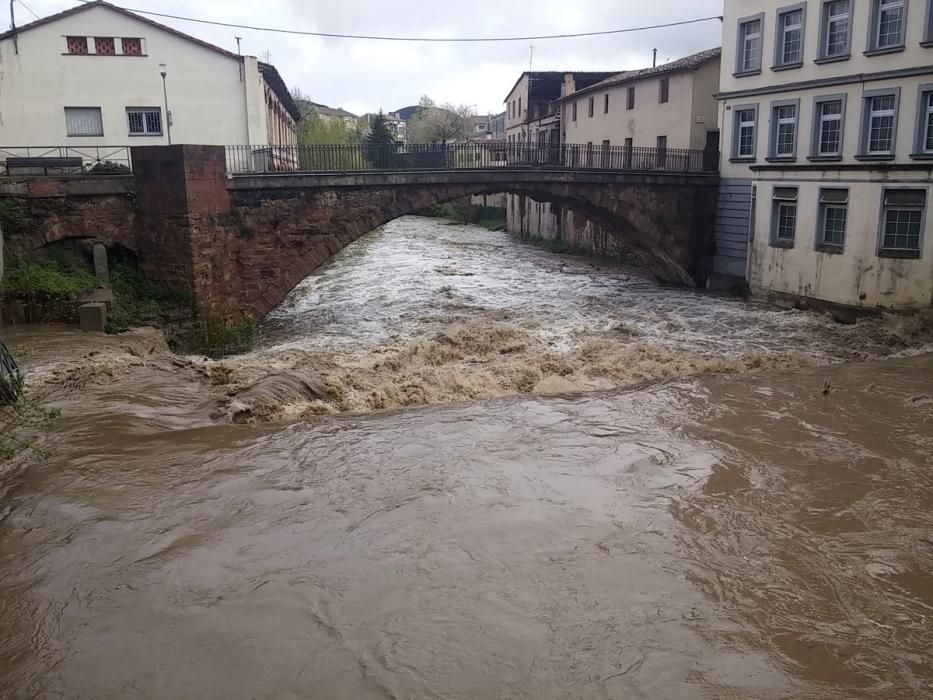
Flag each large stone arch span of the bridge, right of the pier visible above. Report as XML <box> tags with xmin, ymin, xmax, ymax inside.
<box><xmin>220</xmin><ymin>178</ymin><xmax>712</xmax><ymax>317</ymax></box>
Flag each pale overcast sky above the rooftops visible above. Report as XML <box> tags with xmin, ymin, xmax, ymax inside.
<box><xmin>18</xmin><ymin>0</ymin><xmax>722</xmax><ymax>114</ymax></box>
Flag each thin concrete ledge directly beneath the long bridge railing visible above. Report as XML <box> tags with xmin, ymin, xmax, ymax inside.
<box><xmin>227</xmin><ymin>168</ymin><xmax>719</xmax><ymax>190</ymax></box>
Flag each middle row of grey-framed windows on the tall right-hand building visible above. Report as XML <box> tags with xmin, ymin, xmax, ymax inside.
<box><xmin>731</xmin><ymin>84</ymin><xmax>933</xmax><ymax>162</ymax></box>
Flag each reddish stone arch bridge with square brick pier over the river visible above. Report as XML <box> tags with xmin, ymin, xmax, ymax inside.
<box><xmin>0</xmin><ymin>145</ymin><xmax>718</xmax><ymax>320</ymax></box>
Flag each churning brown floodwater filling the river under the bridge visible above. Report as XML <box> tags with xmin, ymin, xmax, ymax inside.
<box><xmin>0</xmin><ymin>218</ymin><xmax>933</xmax><ymax>699</ymax></box>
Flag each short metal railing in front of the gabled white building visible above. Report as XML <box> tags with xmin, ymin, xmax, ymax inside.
<box><xmin>0</xmin><ymin>146</ymin><xmax>133</xmax><ymax>175</ymax></box>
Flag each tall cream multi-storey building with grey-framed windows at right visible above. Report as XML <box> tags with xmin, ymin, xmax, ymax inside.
<box><xmin>717</xmin><ymin>0</ymin><xmax>933</xmax><ymax>308</ymax></box>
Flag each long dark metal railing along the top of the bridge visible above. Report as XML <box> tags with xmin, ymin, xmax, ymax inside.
<box><xmin>226</xmin><ymin>142</ymin><xmax>718</xmax><ymax>174</ymax></box>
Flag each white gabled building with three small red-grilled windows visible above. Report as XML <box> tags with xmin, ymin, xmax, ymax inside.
<box><xmin>0</xmin><ymin>0</ymin><xmax>300</xmax><ymax>159</ymax></box>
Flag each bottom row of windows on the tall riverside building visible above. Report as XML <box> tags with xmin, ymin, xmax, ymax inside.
<box><xmin>770</xmin><ymin>187</ymin><xmax>927</xmax><ymax>258</ymax></box>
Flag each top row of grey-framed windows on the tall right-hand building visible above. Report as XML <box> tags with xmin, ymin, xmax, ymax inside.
<box><xmin>734</xmin><ymin>0</ymin><xmax>933</xmax><ymax>77</ymax></box>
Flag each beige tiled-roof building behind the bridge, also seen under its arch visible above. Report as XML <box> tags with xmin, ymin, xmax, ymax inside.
<box><xmin>506</xmin><ymin>54</ymin><xmax>720</xmax><ymax>263</ymax></box>
